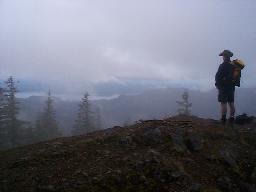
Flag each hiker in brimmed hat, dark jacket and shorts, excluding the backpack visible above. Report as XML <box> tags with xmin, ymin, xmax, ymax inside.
<box><xmin>215</xmin><ymin>50</ymin><xmax>235</xmax><ymax>125</ymax></box>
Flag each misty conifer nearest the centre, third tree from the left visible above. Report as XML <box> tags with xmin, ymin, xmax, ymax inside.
<box><xmin>72</xmin><ymin>93</ymin><xmax>95</xmax><ymax>135</ymax></box>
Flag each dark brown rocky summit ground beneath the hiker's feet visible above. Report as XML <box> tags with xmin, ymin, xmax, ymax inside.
<box><xmin>0</xmin><ymin>116</ymin><xmax>256</xmax><ymax>192</ymax></box>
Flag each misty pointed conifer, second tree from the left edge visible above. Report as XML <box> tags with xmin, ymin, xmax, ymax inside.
<box><xmin>36</xmin><ymin>90</ymin><xmax>61</xmax><ymax>140</ymax></box>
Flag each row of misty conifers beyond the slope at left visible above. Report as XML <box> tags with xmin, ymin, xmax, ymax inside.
<box><xmin>0</xmin><ymin>77</ymin><xmax>101</xmax><ymax>149</ymax></box>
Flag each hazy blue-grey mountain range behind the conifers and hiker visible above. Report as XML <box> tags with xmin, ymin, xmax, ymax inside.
<box><xmin>19</xmin><ymin>88</ymin><xmax>256</xmax><ymax>135</ymax></box>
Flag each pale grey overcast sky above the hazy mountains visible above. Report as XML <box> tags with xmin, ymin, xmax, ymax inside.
<box><xmin>0</xmin><ymin>0</ymin><xmax>256</xmax><ymax>91</ymax></box>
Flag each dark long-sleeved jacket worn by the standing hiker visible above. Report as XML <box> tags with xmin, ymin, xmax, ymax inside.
<box><xmin>215</xmin><ymin>61</ymin><xmax>235</xmax><ymax>89</ymax></box>
